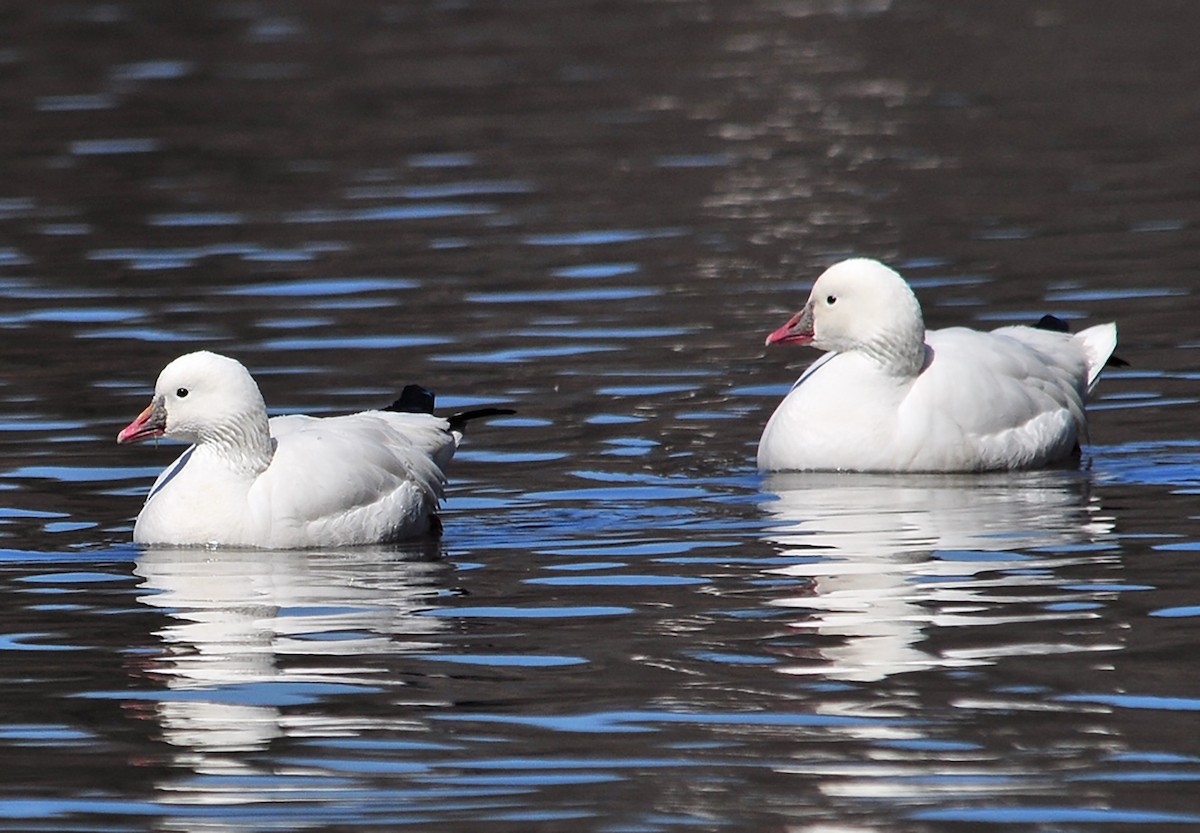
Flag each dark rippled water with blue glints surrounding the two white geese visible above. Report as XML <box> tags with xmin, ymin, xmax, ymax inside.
<box><xmin>0</xmin><ymin>0</ymin><xmax>1200</xmax><ymax>833</ymax></box>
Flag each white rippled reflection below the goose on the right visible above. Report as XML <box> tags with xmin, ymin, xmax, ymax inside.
<box><xmin>763</xmin><ymin>471</ymin><xmax>1112</xmax><ymax>681</ymax></box>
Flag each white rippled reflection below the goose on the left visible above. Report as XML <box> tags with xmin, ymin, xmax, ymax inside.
<box><xmin>134</xmin><ymin>546</ymin><xmax>446</xmax><ymax>757</ymax></box>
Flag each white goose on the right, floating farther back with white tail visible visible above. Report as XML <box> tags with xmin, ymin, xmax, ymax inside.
<box><xmin>758</xmin><ymin>258</ymin><xmax>1117</xmax><ymax>472</ymax></box>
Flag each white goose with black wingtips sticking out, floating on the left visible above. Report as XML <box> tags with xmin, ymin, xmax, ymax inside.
<box><xmin>116</xmin><ymin>350</ymin><xmax>512</xmax><ymax>549</ymax></box>
